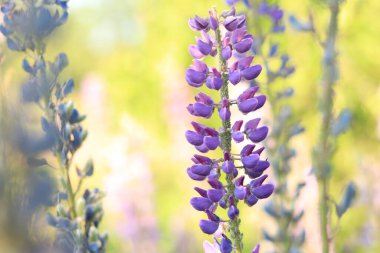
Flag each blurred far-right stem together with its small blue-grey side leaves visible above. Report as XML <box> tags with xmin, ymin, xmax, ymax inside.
<box><xmin>289</xmin><ymin>0</ymin><xmax>356</xmax><ymax>253</ymax></box>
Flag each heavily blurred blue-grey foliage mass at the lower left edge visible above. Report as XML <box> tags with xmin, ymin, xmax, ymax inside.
<box><xmin>0</xmin><ymin>49</ymin><xmax>56</xmax><ymax>253</ymax></box>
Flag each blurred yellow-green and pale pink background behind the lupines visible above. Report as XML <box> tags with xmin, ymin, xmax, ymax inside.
<box><xmin>0</xmin><ymin>0</ymin><xmax>380</xmax><ymax>253</ymax></box>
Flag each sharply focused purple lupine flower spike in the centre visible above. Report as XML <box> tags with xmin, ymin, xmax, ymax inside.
<box><xmin>185</xmin><ymin>9</ymin><xmax>274</xmax><ymax>253</ymax></box>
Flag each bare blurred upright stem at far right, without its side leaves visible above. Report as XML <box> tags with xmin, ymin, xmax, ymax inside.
<box><xmin>315</xmin><ymin>0</ymin><xmax>339</xmax><ymax>253</ymax></box>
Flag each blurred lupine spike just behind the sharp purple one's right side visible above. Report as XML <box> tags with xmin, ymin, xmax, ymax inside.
<box><xmin>227</xmin><ymin>0</ymin><xmax>305</xmax><ymax>252</ymax></box>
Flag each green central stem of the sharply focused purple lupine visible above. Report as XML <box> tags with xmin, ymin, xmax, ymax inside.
<box><xmin>214</xmin><ymin>9</ymin><xmax>243</xmax><ymax>253</ymax></box>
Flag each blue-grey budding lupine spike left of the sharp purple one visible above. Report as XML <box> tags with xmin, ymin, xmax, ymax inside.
<box><xmin>0</xmin><ymin>0</ymin><xmax>108</xmax><ymax>253</ymax></box>
